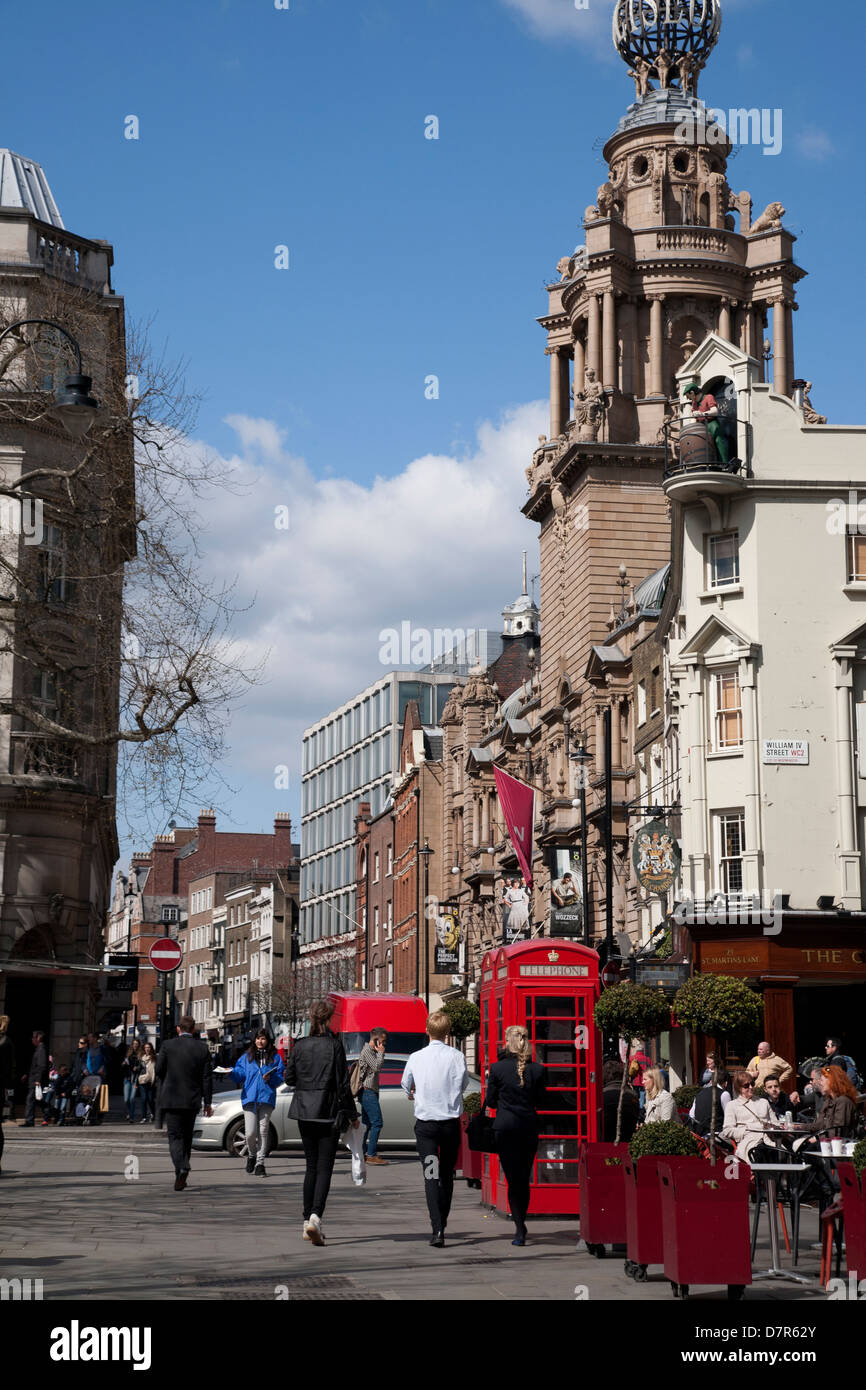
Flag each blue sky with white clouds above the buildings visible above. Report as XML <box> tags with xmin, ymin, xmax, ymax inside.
<box><xmin>0</xmin><ymin>0</ymin><xmax>866</xmax><ymax>850</ymax></box>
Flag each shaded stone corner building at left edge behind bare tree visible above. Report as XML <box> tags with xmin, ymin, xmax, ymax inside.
<box><xmin>0</xmin><ymin>150</ymin><xmax>135</xmax><ymax>1069</ymax></box>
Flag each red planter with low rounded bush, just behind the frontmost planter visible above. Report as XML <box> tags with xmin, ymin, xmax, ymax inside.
<box><xmin>623</xmin><ymin>1120</ymin><xmax>703</xmax><ymax>1283</ymax></box>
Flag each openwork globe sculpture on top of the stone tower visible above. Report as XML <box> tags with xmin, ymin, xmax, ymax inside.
<box><xmin>613</xmin><ymin>0</ymin><xmax>721</xmax><ymax>99</ymax></box>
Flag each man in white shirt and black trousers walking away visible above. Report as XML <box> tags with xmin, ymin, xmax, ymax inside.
<box><xmin>400</xmin><ymin>1009</ymin><xmax>466</xmax><ymax>1250</ymax></box>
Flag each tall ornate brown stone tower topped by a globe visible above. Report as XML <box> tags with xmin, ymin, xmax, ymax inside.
<box><xmin>523</xmin><ymin>0</ymin><xmax>805</xmax><ymax>933</ymax></box>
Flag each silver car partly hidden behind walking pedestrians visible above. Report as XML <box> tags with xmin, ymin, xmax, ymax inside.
<box><xmin>192</xmin><ymin>1056</ymin><xmax>481</xmax><ymax>1156</ymax></box>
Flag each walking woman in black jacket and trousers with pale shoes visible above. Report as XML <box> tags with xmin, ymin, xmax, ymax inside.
<box><xmin>285</xmin><ymin>999</ymin><xmax>360</xmax><ymax>1245</ymax></box>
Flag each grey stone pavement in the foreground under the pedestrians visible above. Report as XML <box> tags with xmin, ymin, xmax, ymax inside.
<box><xmin>0</xmin><ymin>1122</ymin><xmax>839</xmax><ymax>1304</ymax></box>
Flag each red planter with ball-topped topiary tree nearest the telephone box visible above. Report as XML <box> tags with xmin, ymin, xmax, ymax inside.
<box><xmin>577</xmin><ymin>981</ymin><xmax>670</xmax><ymax>1258</ymax></box>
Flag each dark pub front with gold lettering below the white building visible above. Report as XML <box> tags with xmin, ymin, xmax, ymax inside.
<box><xmin>689</xmin><ymin>912</ymin><xmax>866</xmax><ymax>1090</ymax></box>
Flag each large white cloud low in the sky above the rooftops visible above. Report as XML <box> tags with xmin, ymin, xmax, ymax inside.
<box><xmin>187</xmin><ymin>402</ymin><xmax>546</xmax><ymax>806</ymax></box>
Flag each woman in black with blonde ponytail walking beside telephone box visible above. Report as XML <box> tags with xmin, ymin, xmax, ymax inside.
<box><xmin>482</xmin><ymin>1024</ymin><xmax>545</xmax><ymax>1245</ymax></box>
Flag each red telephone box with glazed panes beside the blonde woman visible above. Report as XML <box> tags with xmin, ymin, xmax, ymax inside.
<box><xmin>480</xmin><ymin>937</ymin><xmax>602</xmax><ymax>1216</ymax></box>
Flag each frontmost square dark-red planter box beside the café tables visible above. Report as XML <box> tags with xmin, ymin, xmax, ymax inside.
<box><xmin>657</xmin><ymin>1158</ymin><xmax>752</xmax><ymax>1286</ymax></box>
